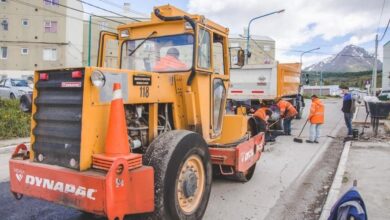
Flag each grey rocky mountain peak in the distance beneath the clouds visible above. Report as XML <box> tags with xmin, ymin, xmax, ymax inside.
<box><xmin>304</xmin><ymin>45</ymin><xmax>382</xmax><ymax>72</ymax></box>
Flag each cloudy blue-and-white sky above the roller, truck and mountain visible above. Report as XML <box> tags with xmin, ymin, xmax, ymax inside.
<box><xmin>84</xmin><ymin>0</ymin><xmax>390</xmax><ymax>66</ymax></box>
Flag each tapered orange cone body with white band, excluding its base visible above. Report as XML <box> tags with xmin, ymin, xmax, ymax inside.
<box><xmin>105</xmin><ymin>83</ymin><xmax>130</xmax><ymax>156</ymax></box>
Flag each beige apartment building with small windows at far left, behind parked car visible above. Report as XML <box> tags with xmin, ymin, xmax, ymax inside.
<box><xmin>0</xmin><ymin>0</ymin><xmax>83</xmax><ymax>75</ymax></box>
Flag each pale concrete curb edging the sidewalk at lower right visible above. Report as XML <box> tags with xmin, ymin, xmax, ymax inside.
<box><xmin>319</xmin><ymin>141</ymin><xmax>351</xmax><ymax>220</ymax></box>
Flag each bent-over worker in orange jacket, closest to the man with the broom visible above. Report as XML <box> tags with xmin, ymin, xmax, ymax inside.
<box><xmin>275</xmin><ymin>97</ymin><xmax>298</xmax><ymax>135</ymax></box>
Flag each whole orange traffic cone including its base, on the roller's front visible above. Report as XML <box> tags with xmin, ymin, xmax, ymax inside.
<box><xmin>92</xmin><ymin>83</ymin><xmax>142</xmax><ymax>170</ymax></box>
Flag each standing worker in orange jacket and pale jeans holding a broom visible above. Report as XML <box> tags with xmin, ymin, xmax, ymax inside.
<box><xmin>306</xmin><ymin>95</ymin><xmax>325</xmax><ymax>144</ymax></box>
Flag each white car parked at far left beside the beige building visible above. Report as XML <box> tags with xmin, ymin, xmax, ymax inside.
<box><xmin>0</xmin><ymin>78</ymin><xmax>33</xmax><ymax>99</ymax></box>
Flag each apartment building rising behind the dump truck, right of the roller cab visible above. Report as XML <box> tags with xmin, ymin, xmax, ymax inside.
<box><xmin>229</xmin><ymin>34</ymin><xmax>275</xmax><ymax>66</ymax></box>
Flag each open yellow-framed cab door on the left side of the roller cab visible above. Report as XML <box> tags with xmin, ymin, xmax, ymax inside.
<box><xmin>97</xmin><ymin>31</ymin><xmax>119</xmax><ymax>68</ymax></box>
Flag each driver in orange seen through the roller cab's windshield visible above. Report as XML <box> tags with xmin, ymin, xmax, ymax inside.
<box><xmin>153</xmin><ymin>47</ymin><xmax>188</xmax><ymax>72</ymax></box>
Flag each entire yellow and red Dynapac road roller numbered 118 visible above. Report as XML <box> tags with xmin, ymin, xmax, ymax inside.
<box><xmin>10</xmin><ymin>5</ymin><xmax>264</xmax><ymax>219</ymax></box>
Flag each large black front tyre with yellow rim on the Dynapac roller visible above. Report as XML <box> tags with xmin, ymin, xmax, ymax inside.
<box><xmin>144</xmin><ymin>130</ymin><xmax>212</xmax><ymax>220</ymax></box>
